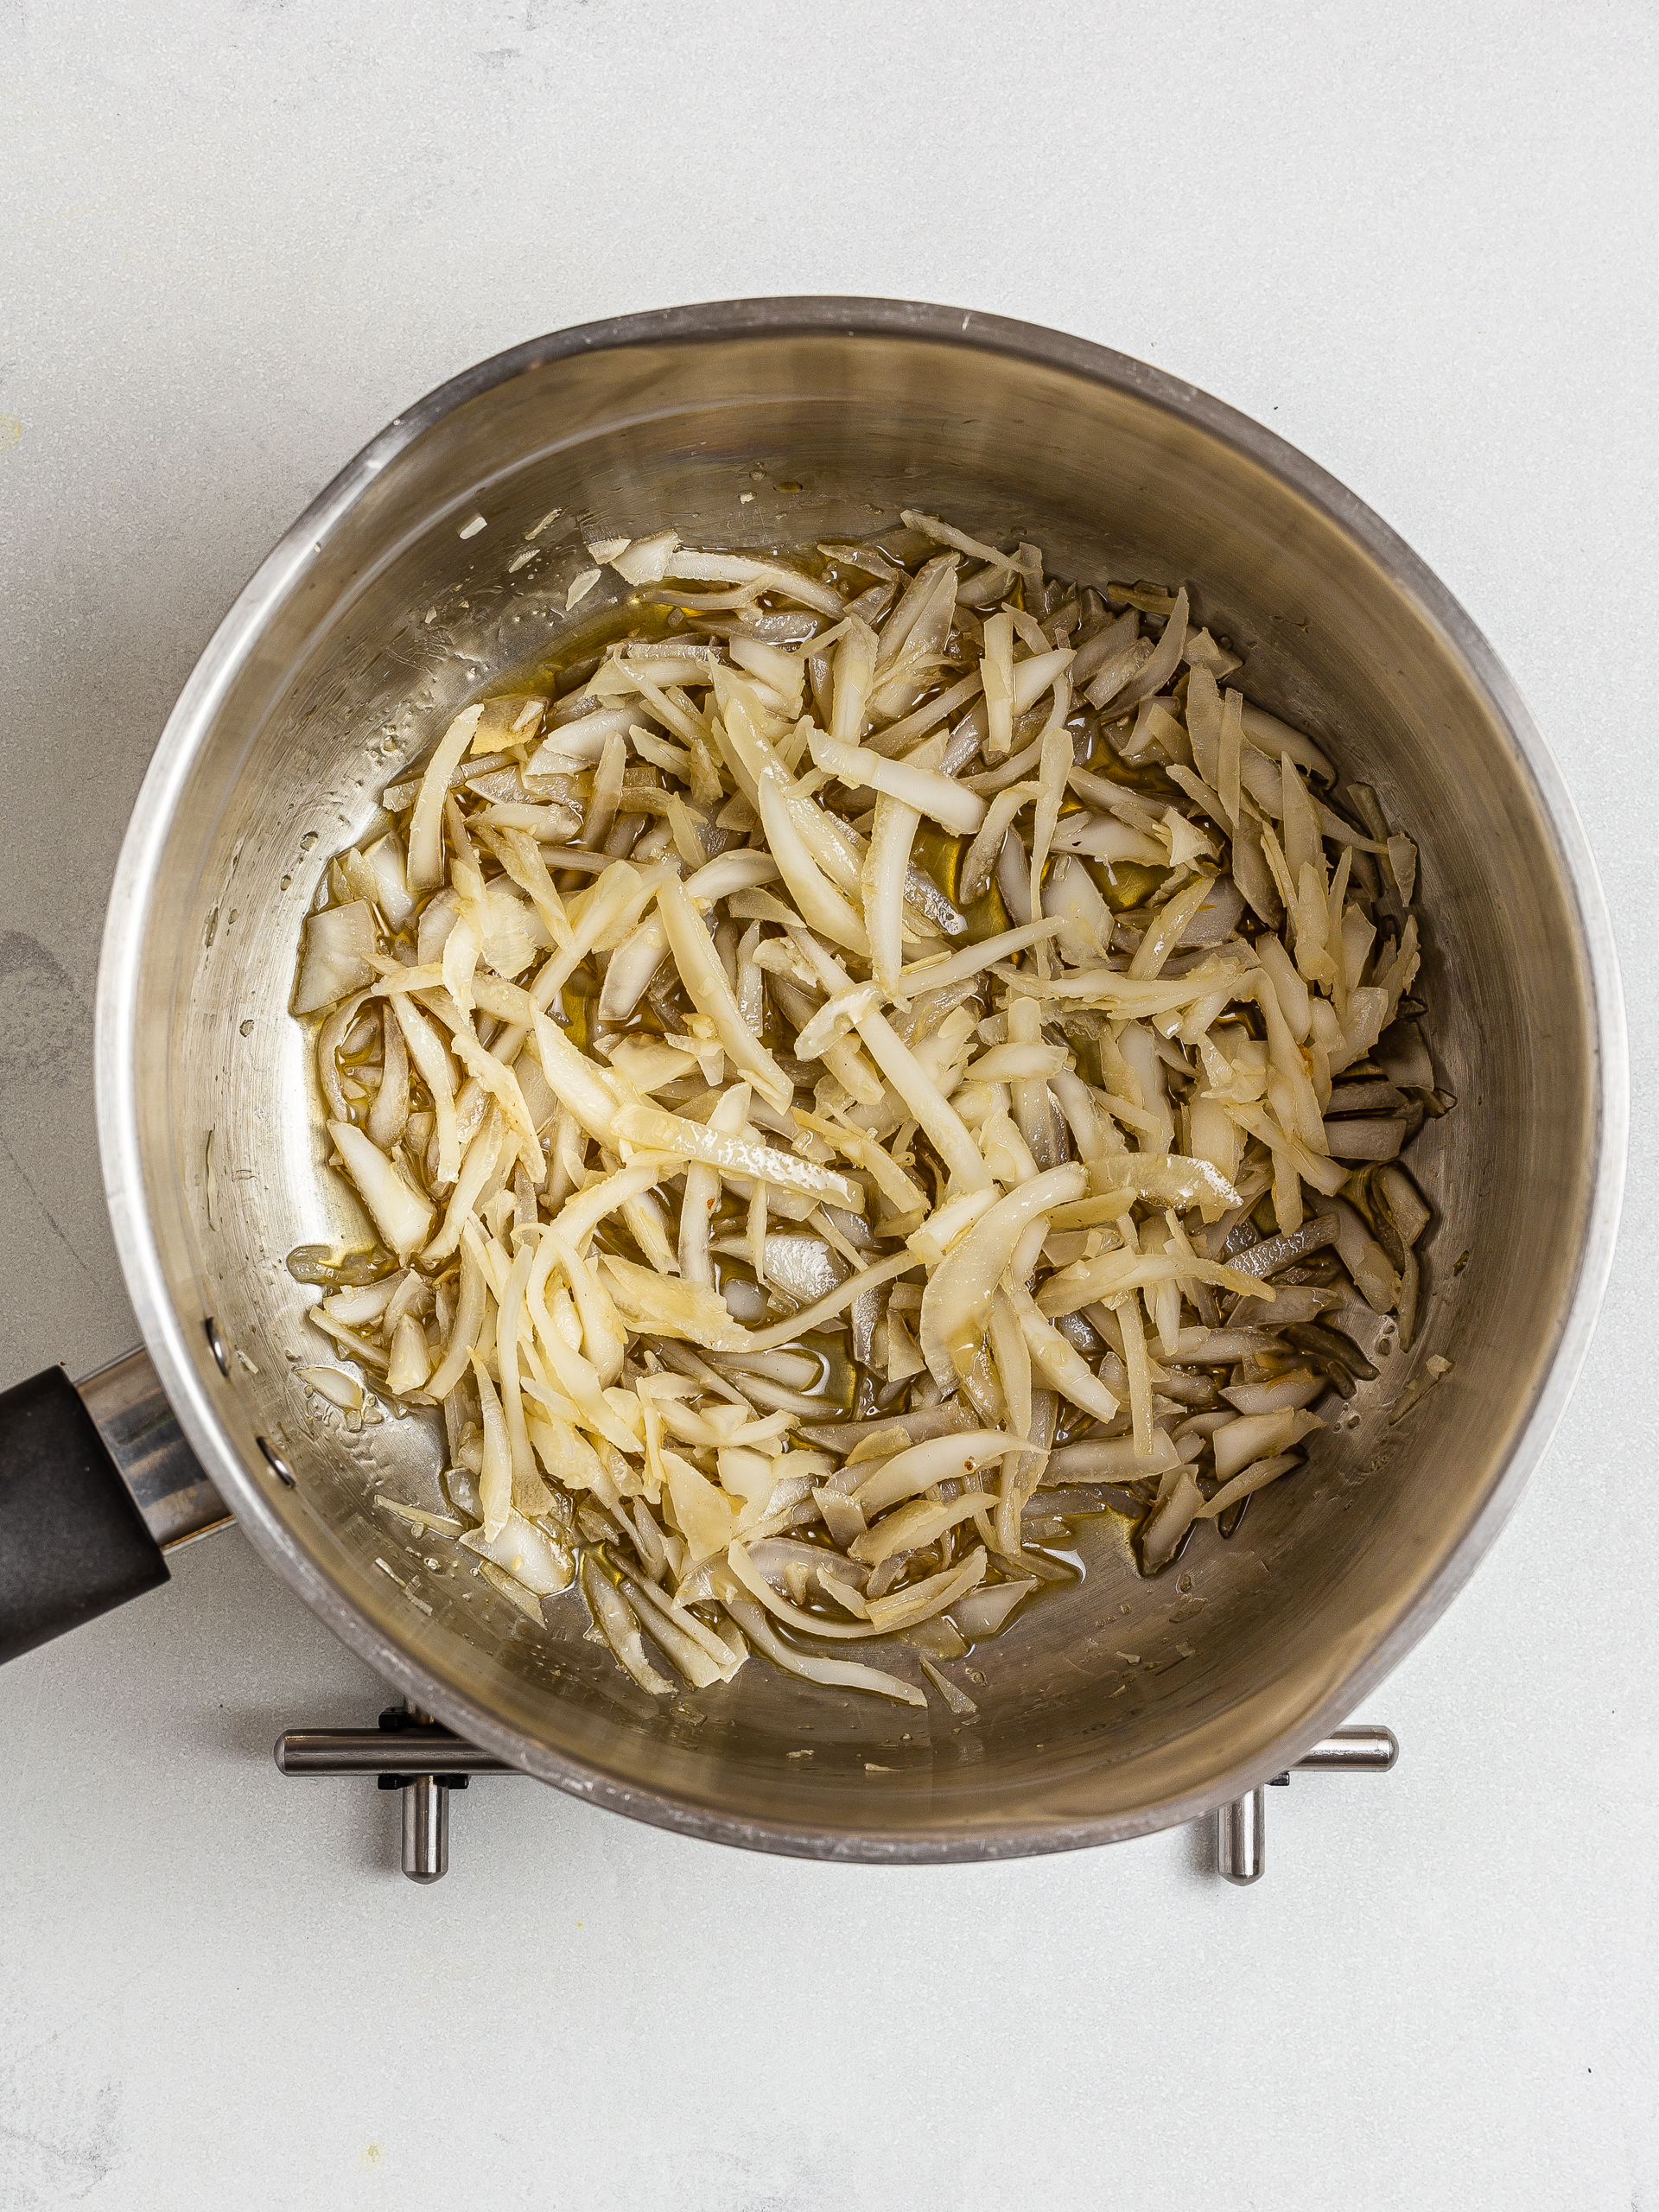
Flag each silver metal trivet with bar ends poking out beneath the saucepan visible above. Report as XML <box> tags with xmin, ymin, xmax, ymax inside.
<box><xmin>276</xmin><ymin>1706</ymin><xmax>1400</xmax><ymax>1883</ymax></box>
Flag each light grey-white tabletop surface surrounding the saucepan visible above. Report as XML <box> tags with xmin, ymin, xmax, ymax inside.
<box><xmin>0</xmin><ymin>0</ymin><xmax>1659</xmax><ymax>2212</ymax></box>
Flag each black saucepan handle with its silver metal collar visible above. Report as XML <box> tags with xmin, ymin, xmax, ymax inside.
<box><xmin>0</xmin><ymin>1351</ymin><xmax>230</xmax><ymax>1663</ymax></box>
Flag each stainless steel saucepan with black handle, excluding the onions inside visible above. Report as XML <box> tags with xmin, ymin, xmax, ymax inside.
<box><xmin>0</xmin><ymin>299</ymin><xmax>1626</xmax><ymax>1860</ymax></box>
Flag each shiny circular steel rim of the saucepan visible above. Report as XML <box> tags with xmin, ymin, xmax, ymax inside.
<box><xmin>98</xmin><ymin>296</ymin><xmax>1630</xmax><ymax>1865</ymax></box>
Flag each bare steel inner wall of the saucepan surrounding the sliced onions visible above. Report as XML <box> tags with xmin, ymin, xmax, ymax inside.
<box><xmin>119</xmin><ymin>332</ymin><xmax>1597</xmax><ymax>1856</ymax></box>
